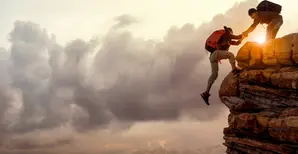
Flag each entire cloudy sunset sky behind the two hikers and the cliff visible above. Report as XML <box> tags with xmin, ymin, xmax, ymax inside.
<box><xmin>0</xmin><ymin>0</ymin><xmax>298</xmax><ymax>154</ymax></box>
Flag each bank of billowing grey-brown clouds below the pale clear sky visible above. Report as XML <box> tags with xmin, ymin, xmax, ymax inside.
<box><xmin>0</xmin><ymin>1</ymin><xmax>270</xmax><ymax>154</ymax></box>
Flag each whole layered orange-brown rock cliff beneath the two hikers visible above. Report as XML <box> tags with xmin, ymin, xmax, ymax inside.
<box><xmin>219</xmin><ymin>34</ymin><xmax>298</xmax><ymax>154</ymax></box>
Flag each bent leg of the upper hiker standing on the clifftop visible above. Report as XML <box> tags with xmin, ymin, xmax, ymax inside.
<box><xmin>266</xmin><ymin>17</ymin><xmax>283</xmax><ymax>41</ymax></box>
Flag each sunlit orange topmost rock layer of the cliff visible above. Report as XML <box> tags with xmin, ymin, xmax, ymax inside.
<box><xmin>236</xmin><ymin>33</ymin><xmax>298</xmax><ymax>68</ymax></box>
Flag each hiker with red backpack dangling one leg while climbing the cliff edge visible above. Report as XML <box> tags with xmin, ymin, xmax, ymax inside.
<box><xmin>201</xmin><ymin>26</ymin><xmax>243</xmax><ymax>105</ymax></box>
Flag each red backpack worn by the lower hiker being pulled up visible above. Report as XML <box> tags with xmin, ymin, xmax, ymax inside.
<box><xmin>205</xmin><ymin>29</ymin><xmax>226</xmax><ymax>53</ymax></box>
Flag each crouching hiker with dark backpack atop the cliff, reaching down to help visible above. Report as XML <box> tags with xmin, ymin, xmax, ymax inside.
<box><xmin>242</xmin><ymin>0</ymin><xmax>283</xmax><ymax>41</ymax></box>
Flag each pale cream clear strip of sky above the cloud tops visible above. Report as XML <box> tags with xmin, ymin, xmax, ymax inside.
<box><xmin>0</xmin><ymin>0</ymin><xmax>253</xmax><ymax>46</ymax></box>
